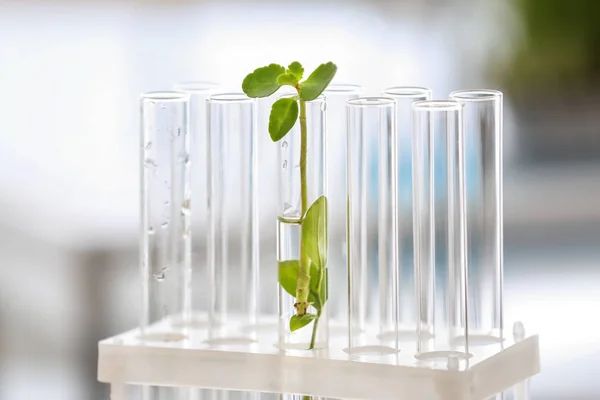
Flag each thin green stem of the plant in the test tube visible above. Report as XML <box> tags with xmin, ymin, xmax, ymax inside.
<box><xmin>295</xmin><ymin>99</ymin><xmax>310</xmax><ymax>316</ymax></box>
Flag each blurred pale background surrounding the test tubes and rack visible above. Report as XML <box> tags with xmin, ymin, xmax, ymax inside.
<box><xmin>0</xmin><ymin>0</ymin><xmax>600</xmax><ymax>400</ymax></box>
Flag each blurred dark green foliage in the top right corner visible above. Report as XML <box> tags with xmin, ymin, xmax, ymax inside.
<box><xmin>496</xmin><ymin>0</ymin><xmax>600</xmax><ymax>91</ymax></box>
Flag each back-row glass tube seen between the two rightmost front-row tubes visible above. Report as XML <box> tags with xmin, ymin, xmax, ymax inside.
<box><xmin>383</xmin><ymin>86</ymin><xmax>431</xmax><ymax>341</ymax></box>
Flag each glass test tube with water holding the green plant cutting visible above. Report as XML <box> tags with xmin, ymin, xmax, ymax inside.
<box><xmin>277</xmin><ymin>95</ymin><xmax>329</xmax><ymax>350</ymax></box>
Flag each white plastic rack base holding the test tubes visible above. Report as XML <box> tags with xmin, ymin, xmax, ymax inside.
<box><xmin>98</xmin><ymin>323</ymin><xmax>540</xmax><ymax>400</ymax></box>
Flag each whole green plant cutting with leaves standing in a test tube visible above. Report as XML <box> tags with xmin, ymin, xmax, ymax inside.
<box><xmin>242</xmin><ymin>61</ymin><xmax>337</xmax><ymax>349</ymax></box>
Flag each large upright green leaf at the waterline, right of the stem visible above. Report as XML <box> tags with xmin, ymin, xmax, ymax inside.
<box><xmin>302</xmin><ymin>196</ymin><xmax>327</xmax><ymax>269</ymax></box>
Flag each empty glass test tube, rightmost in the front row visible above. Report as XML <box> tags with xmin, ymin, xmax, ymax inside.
<box><xmin>413</xmin><ymin>101</ymin><xmax>468</xmax><ymax>362</ymax></box>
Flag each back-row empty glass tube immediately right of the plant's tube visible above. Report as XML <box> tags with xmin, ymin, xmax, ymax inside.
<box><xmin>323</xmin><ymin>83</ymin><xmax>363</xmax><ymax>335</ymax></box>
